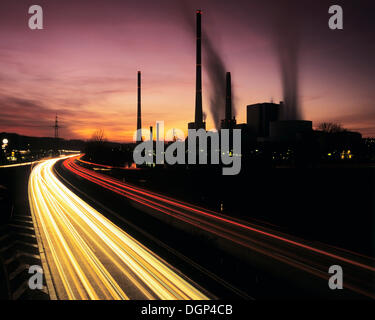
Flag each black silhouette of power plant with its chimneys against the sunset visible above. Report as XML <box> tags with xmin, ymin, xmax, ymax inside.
<box><xmin>131</xmin><ymin>10</ymin><xmax>363</xmax><ymax>170</ymax></box>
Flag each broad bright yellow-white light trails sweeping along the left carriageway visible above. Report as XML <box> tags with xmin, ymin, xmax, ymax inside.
<box><xmin>28</xmin><ymin>159</ymin><xmax>208</xmax><ymax>300</ymax></box>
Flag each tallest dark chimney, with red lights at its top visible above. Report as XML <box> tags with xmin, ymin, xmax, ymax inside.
<box><xmin>195</xmin><ymin>10</ymin><xmax>203</xmax><ymax>129</ymax></box>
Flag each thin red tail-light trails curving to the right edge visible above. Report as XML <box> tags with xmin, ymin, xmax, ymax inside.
<box><xmin>63</xmin><ymin>158</ymin><xmax>375</xmax><ymax>298</ymax></box>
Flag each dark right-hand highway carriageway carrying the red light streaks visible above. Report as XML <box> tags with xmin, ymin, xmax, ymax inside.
<box><xmin>63</xmin><ymin>158</ymin><xmax>375</xmax><ymax>299</ymax></box>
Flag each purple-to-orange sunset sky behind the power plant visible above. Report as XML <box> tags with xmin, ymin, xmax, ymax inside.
<box><xmin>0</xmin><ymin>0</ymin><xmax>375</xmax><ymax>142</ymax></box>
